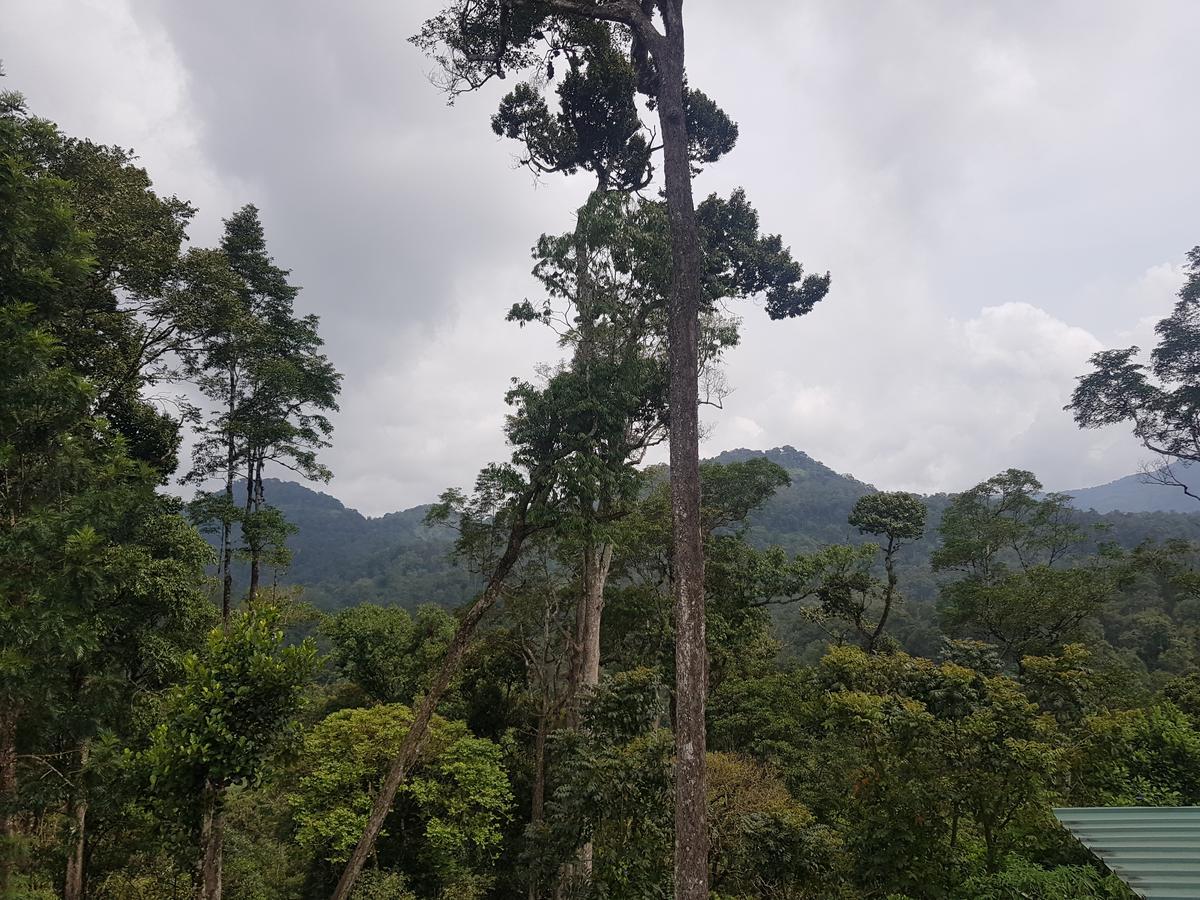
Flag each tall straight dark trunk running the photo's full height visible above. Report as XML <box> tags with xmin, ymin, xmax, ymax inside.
<box><xmin>654</xmin><ymin>0</ymin><xmax>708</xmax><ymax>900</ymax></box>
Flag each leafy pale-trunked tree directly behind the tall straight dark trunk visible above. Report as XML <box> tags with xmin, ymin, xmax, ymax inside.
<box><xmin>509</xmin><ymin>191</ymin><xmax>803</xmax><ymax>720</ymax></box>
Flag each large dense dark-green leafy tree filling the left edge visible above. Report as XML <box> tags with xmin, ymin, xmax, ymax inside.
<box><xmin>0</xmin><ymin>95</ymin><xmax>208</xmax><ymax>900</ymax></box>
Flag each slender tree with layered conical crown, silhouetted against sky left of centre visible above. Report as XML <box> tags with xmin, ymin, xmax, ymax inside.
<box><xmin>186</xmin><ymin>205</ymin><xmax>341</xmax><ymax>617</ymax></box>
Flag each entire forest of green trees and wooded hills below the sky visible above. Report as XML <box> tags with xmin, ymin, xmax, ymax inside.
<box><xmin>0</xmin><ymin>0</ymin><xmax>1200</xmax><ymax>900</ymax></box>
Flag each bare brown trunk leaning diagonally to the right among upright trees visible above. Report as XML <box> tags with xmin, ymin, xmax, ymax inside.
<box><xmin>331</xmin><ymin>494</ymin><xmax>536</xmax><ymax>900</ymax></box>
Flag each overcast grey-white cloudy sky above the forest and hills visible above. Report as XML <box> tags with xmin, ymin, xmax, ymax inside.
<box><xmin>0</xmin><ymin>0</ymin><xmax>1200</xmax><ymax>515</ymax></box>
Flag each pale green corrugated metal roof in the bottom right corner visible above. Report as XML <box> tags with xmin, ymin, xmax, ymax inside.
<box><xmin>1054</xmin><ymin>806</ymin><xmax>1200</xmax><ymax>900</ymax></box>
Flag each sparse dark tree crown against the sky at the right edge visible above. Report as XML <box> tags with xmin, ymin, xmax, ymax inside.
<box><xmin>1064</xmin><ymin>246</ymin><xmax>1200</xmax><ymax>499</ymax></box>
